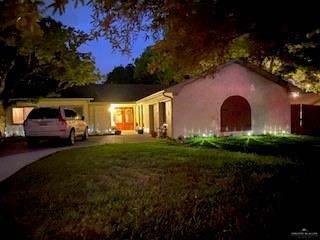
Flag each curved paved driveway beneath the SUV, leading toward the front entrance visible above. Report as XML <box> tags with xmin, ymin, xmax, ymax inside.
<box><xmin>0</xmin><ymin>134</ymin><xmax>157</xmax><ymax>182</ymax></box>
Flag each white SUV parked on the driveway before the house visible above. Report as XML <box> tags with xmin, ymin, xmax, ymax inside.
<box><xmin>23</xmin><ymin>107</ymin><xmax>88</xmax><ymax>146</ymax></box>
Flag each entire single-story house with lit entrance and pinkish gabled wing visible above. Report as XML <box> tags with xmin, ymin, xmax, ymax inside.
<box><xmin>1</xmin><ymin>60</ymin><xmax>320</xmax><ymax>138</ymax></box>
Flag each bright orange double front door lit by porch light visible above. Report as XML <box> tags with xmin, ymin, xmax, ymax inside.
<box><xmin>114</xmin><ymin>107</ymin><xmax>134</xmax><ymax>130</ymax></box>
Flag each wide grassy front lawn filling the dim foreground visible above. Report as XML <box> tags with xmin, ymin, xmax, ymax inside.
<box><xmin>0</xmin><ymin>142</ymin><xmax>319</xmax><ymax>239</ymax></box>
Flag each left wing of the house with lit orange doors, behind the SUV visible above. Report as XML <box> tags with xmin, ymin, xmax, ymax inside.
<box><xmin>5</xmin><ymin>84</ymin><xmax>161</xmax><ymax>136</ymax></box>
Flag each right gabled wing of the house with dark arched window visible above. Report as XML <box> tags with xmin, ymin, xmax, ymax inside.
<box><xmin>137</xmin><ymin>60</ymin><xmax>320</xmax><ymax>138</ymax></box>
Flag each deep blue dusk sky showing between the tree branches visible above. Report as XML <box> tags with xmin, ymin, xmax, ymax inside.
<box><xmin>47</xmin><ymin>2</ymin><xmax>153</xmax><ymax>74</ymax></box>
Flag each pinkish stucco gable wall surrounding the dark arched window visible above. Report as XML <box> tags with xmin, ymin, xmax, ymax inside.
<box><xmin>173</xmin><ymin>63</ymin><xmax>290</xmax><ymax>138</ymax></box>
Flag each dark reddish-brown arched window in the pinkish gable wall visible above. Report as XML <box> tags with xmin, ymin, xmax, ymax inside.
<box><xmin>220</xmin><ymin>96</ymin><xmax>251</xmax><ymax>132</ymax></box>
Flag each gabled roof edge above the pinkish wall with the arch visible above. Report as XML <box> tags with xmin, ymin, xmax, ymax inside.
<box><xmin>166</xmin><ymin>60</ymin><xmax>301</xmax><ymax>92</ymax></box>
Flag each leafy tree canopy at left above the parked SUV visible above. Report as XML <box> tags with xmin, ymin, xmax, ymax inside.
<box><xmin>0</xmin><ymin>0</ymin><xmax>99</xmax><ymax>104</ymax></box>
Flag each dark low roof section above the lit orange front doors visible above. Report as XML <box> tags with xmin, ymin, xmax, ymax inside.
<box><xmin>61</xmin><ymin>84</ymin><xmax>161</xmax><ymax>102</ymax></box>
